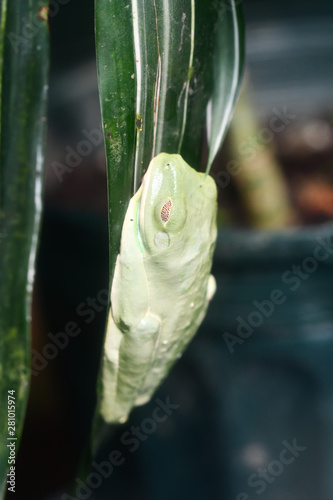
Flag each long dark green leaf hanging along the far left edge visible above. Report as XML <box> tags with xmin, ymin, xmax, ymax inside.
<box><xmin>0</xmin><ymin>0</ymin><xmax>49</xmax><ymax>494</ymax></box>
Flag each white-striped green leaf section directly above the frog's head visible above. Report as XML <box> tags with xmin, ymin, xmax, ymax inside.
<box><xmin>132</xmin><ymin>0</ymin><xmax>195</xmax><ymax>191</ymax></box>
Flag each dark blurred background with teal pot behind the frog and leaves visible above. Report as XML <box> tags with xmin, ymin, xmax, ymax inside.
<box><xmin>6</xmin><ymin>0</ymin><xmax>333</xmax><ymax>500</ymax></box>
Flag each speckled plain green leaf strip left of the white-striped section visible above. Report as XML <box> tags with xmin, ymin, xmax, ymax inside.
<box><xmin>95</xmin><ymin>0</ymin><xmax>136</xmax><ymax>284</ymax></box>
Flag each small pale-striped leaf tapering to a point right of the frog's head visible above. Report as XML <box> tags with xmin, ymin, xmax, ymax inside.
<box><xmin>206</xmin><ymin>0</ymin><xmax>244</xmax><ymax>173</ymax></box>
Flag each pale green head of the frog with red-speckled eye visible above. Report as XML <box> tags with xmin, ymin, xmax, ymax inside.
<box><xmin>137</xmin><ymin>153</ymin><xmax>217</xmax><ymax>255</ymax></box>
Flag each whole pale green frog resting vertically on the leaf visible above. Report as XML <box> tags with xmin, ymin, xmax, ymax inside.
<box><xmin>101</xmin><ymin>153</ymin><xmax>217</xmax><ymax>422</ymax></box>
